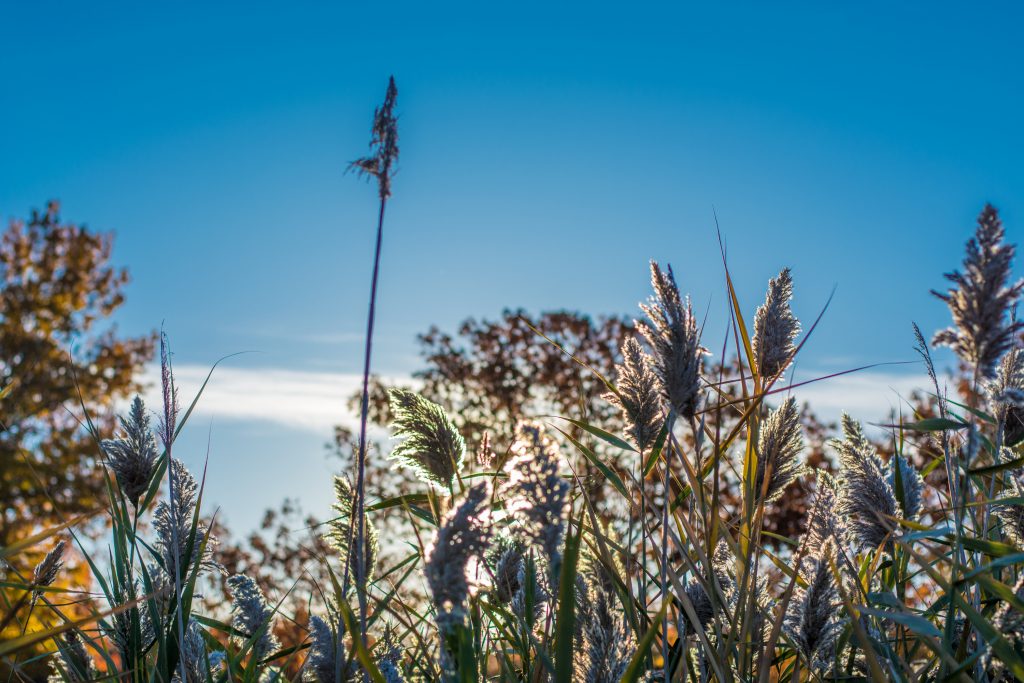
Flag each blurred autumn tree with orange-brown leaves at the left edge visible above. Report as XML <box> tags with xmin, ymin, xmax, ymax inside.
<box><xmin>0</xmin><ymin>202</ymin><xmax>154</xmax><ymax>545</ymax></box>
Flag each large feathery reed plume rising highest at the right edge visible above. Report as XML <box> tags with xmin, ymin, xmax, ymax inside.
<box><xmin>932</xmin><ymin>204</ymin><xmax>1024</xmax><ymax>378</ymax></box>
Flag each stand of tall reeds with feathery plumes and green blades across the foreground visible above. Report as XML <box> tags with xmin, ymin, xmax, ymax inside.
<box><xmin>0</xmin><ymin>82</ymin><xmax>1024</xmax><ymax>683</ymax></box>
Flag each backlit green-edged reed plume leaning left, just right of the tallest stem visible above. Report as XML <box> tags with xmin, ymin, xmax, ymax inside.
<box><xmin>391</xmin><ymin>389</ymin><xmax>466</xmax><ymax>490</ymax></box>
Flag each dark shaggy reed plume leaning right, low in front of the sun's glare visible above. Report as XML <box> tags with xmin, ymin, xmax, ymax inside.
<box><xmin>424</xmin><ymin>483</ymin><xmax>490</xmax><ymax>618</ymax></box>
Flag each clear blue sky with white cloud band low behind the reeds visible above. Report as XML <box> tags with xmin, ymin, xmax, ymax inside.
<box><xmin>0</xmin><ymin>2</ymin><xmax>1024</xmax><ymax>528</ymax></box>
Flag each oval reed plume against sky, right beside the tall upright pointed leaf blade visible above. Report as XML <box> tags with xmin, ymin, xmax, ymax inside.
<box><xmin>751</xmin><ymin>268</ymin><xmax>800</xmax><ymax>380</ymax></box>
